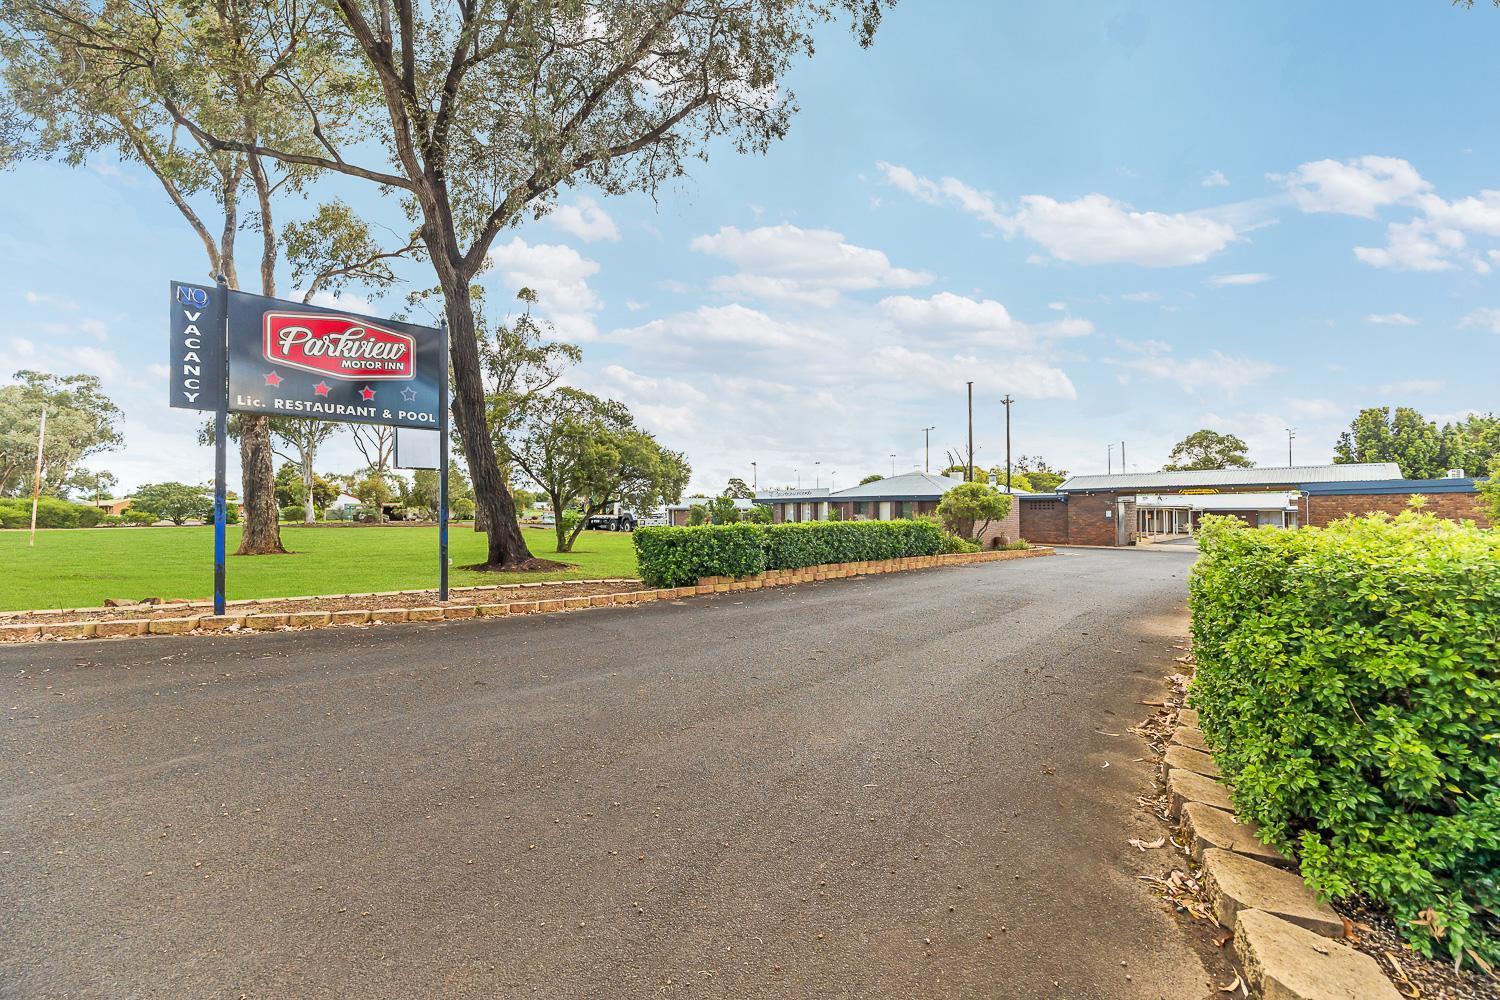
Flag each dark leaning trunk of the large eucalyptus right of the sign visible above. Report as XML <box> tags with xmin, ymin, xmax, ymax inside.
<box><xmin>429</xmin><ymin>265</ymin><xmax>533</xmax><ymax>567</ymax></box>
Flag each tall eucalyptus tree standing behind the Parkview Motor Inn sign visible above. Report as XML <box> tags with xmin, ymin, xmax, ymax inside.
<box><xmin>0</xmin><ymin>0</ymin><xmax>357</xmax><ymax>555</ymax></box>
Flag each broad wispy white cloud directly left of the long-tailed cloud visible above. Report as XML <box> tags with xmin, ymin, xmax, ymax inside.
<box><xmin>692</xmin><ymin>222</ymin><xmax>933</xmax><ymax>307</ymax></box>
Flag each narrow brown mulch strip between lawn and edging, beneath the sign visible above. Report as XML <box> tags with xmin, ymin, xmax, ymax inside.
<box><xmin>0</xmin><ymin>580</ymin><xmax>645</xmax><ymax>625</ymax></box>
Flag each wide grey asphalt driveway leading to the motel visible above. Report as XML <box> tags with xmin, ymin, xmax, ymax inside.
<box><xmin>0</xmin><ymin>550</ymin><xmax>1212</xmax><ymax>999</ymax></box>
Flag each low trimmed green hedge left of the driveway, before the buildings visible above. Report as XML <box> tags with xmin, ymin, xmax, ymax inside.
<box><xmin>635</xmin><ymin>520</ymin><xmax>942</xmax><ymax>586</ymax></box>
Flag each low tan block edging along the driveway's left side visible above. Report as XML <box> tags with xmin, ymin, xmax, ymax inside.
<box><xmin>0</xmin><ymin>547</ymin><xmax>1056</xmax><ymax>643</ymax></box>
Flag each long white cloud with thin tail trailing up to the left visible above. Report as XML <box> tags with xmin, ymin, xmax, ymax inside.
<box><xmin>876</xmin><ymin>162</ymin><xmax>1235</xmax><ymax>267</ymax></box>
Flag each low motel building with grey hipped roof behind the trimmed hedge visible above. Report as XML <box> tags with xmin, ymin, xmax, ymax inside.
<box><xmin>755</xmin><ymin>472</ymin><xmax>1026</xmax><ymax>541</ymax></box>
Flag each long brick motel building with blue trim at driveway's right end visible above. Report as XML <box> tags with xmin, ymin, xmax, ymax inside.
<box><xmin>1017</xmin><ymin>462</ymin><xmax>1488</xmax><ymax>546</ymax></box>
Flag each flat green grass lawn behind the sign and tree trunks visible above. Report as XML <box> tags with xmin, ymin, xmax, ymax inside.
<box><xmin>0</xmin><ymin>525</ymin><xmax>636</xmax><ymax>610</ymax></box>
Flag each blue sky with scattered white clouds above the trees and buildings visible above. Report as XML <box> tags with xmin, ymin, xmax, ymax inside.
<box><xmin>0</xmin><ymin>0</ymin><xmax>1500</xmax><ymax>490</ymax></box>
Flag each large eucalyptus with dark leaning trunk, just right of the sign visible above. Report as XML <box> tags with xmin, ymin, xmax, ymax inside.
<box><xmin>73</xmin><ymin>0</ymin><xmax>894</xmax><ymax>565</ymax></box>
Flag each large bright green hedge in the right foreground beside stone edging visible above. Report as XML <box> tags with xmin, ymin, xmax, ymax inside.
<box><xmin>1190</xmin><ymin>511</ymin><xmax>1500</xmax><ymax>963</ymax></box>
